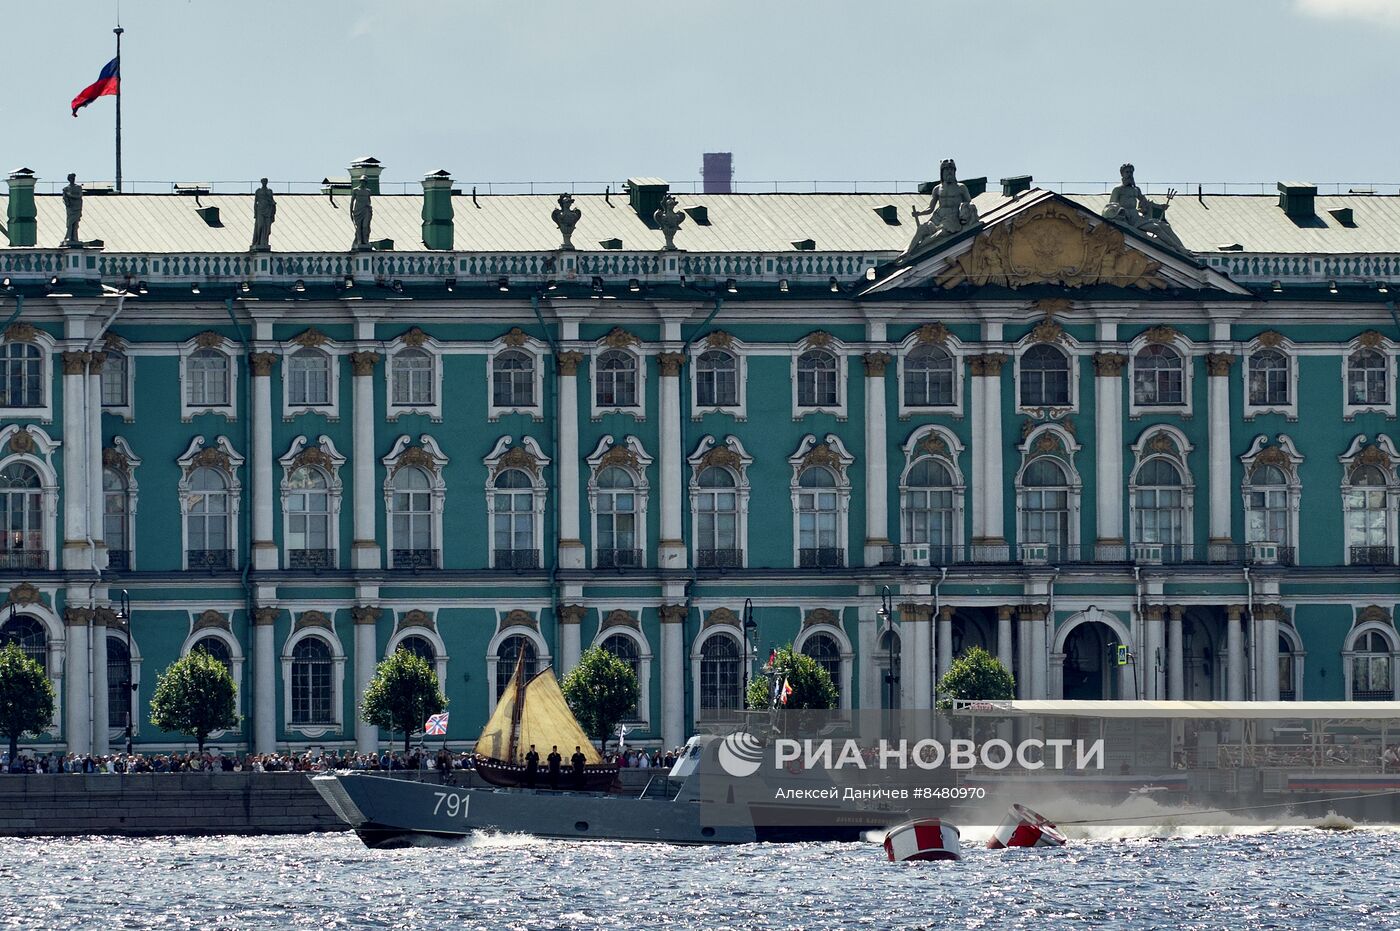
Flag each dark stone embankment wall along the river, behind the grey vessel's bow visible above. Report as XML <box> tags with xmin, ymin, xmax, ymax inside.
<box><xmin>0</xmin><ymin>770</ymin><xmax>664</xmax><ymax>836</ymax></box>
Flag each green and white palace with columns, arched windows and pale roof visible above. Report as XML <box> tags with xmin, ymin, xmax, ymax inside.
<box><xmin>0</xmin><ymin>160</ymin><xmax>1400</xmax><ymax>752</ymax></box>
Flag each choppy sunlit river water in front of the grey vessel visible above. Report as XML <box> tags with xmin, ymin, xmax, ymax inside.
<box><xmin>0</xmin><ymin>825</ymin><xmax>1400</xmax><ymax>931</ymax></box>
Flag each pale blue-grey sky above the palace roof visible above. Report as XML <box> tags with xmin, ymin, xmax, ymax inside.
<box><xmin>8</xmin><ymin>0</ymin><xmax>1400</xmax><ymax>190</ymax></box>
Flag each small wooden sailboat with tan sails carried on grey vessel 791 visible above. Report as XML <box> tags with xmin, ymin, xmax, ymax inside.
<box><xmin>476</xmin><ymin>654</ymin><xmax>617</xmax><ymax>792</ymax></box>
